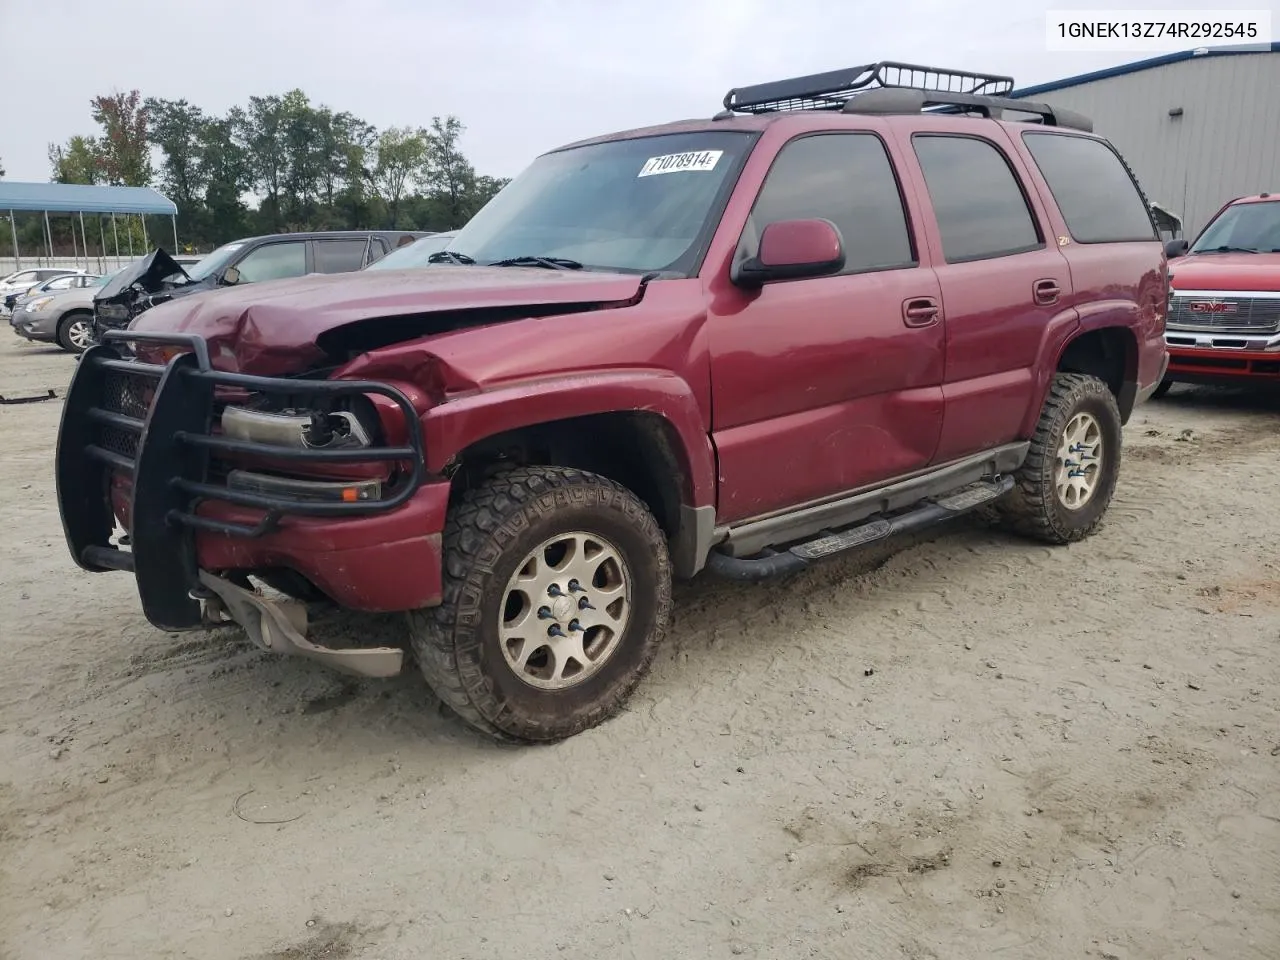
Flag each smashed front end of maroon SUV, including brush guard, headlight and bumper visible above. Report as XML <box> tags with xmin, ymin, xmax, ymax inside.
<box><xmin>56</xmin><ymin>332</ymin><xmax>437</xmax><ymax>676</ymax></box>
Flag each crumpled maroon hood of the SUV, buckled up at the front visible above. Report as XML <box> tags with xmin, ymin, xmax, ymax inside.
<box><xmin>129</xmin><ymin>271</ymin><xmax>643</xmax><ymax>376</ymax></box>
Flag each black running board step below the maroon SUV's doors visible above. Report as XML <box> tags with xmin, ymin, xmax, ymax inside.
<box><xmin>707</xmin><ymin>476</ymin><xmax>1014</xmax><ymax>580</ymax></box>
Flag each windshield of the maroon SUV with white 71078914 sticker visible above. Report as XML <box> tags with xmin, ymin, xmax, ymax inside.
<box><xmin>448</xmin><ymin>131</ymin><xmax>753</xmax><ymax>276</ymax></box>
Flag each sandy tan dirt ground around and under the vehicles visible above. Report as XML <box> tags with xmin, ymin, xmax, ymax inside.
<box><xmin>0</xmin><ymin>328</ymin><xmax>1280</xmax><ymax>960</ymax></box>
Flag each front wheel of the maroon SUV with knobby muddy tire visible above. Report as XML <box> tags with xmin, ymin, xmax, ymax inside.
<box><xmin>410</xmin><ymin>467</ymin><xmax>672</xmax><ymax>741</ymax></box>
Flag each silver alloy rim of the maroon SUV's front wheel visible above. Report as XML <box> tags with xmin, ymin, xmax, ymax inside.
<box><xmin>499</xmin><ymin>531</ymin><xmax>631</xmax><ymax>690</ymax></box>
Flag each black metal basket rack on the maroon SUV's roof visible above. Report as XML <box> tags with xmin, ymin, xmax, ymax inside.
<box><xmin>721</xmin><ymin>60</ymin><xmax>1093</xmax><ymax>131</ymax></box>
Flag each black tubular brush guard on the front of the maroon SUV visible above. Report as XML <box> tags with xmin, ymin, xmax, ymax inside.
<box><xmin>55</xmin><ymin>330</ymin><xmax>426</xmax><ymax>630</ymax></box>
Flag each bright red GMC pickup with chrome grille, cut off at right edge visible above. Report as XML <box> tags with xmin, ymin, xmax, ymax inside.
<box><xmin>1153</xmin><ymin>193</ymin><xmax>1280</xmax><ymax>397</ymax></box>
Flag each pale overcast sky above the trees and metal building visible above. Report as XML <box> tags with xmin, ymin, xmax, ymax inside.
<box><xmin>0</xmin><ymin>0</ymin><xmax>1280</xmax><ymax>180</ymax></box>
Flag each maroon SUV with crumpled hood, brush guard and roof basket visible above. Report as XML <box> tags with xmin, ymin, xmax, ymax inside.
<box><xmin>56</xmin><ymin>63</ymin><xmax>1169</xmax><ymax>741</ymax></box>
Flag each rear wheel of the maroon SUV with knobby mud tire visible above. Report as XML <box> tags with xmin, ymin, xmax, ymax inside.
<box><xmin>997</xmin><ymin>374</ymin><xmax>1121</xmax><ymax>544</ymax></box>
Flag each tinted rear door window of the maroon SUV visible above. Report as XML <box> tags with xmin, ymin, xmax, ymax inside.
<box><xmin>913</xmin><ymin>133</ymin><xmax>1043</xmax><ymax>264</ymax></box>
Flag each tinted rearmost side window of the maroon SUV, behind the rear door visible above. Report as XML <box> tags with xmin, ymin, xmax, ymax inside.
<box><xmin>1023</xmin><ymin>133</ymin><xmax>1157</xmax><ymax>243</ymax></box>
